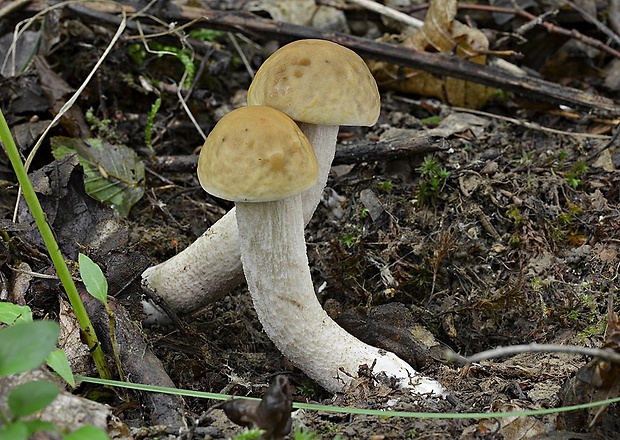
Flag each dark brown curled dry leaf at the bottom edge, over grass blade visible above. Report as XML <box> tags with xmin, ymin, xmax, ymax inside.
<box><xmin>221</xmin><ymin>375</ymin><xmax>293</xmax><ymax>440</ymax></box>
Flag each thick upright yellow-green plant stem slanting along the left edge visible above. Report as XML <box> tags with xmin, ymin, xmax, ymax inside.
<box><xmin>0</xmin><ymin>110</ymin><xmax>112</xmax><ymax>379</ymax></box>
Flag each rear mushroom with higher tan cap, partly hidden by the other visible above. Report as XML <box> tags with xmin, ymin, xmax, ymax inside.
<box><xmin>142</xmin><ymin>40</ymin><xmax>380</xmax><ymax>314</ymax></box>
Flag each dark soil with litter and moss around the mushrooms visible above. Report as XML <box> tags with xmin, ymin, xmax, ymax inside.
<box><xmin>0</xmin><ymin>0</ymin><xmax>620</xmax><ymax>439</ymax></box>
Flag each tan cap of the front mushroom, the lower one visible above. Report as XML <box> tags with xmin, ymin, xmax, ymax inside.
<box><xmin>198</xmin><ymin>106</ymin><xmax>318</xmax><ymax>202</ymax></box>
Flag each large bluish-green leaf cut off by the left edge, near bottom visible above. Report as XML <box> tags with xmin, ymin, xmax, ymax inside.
<box><xmin>0</xmin><ymin>321</ymin><xmax>60</xmax><ymax>376</ymax></box>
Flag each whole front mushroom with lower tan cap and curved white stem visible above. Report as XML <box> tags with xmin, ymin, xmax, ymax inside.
<box><xmin>198</xmin><ymin>106</ymin><xmax>443</xmax><ymax>395</ymax></box>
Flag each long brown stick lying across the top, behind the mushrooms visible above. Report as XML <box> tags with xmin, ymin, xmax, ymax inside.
<box><xmin>13</xmin><ymin>2</ymin><xmax>620</xmax><ymax>117</ymax></box>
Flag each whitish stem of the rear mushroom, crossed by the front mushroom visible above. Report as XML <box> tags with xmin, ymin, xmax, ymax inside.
<box><xmin>142</xmin><ymin>123</ymin><xmax>339</xmax><ymax>314</ymax></box>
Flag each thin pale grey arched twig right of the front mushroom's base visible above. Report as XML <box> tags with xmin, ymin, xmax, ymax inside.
<box><xmin>445</xmin><ymin>344</ymin><xmax>620</xmax><ymax>365</ymax></box>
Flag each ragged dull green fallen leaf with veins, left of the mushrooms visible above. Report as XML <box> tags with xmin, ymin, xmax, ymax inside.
<box><xmin>50</xmin><ymin>137</ymin><xmax>144</xmax><ymax>217</ymax></box>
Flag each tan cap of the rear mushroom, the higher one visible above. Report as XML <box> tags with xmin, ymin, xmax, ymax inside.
<box><xmin>248</xmin><ymin>40</ymin><xmax>381</xmax><ymax>126</ymax></box>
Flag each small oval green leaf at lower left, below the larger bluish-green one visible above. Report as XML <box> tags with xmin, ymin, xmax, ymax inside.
<box><xmin>7</xmin><ymin>380</ymin><xmax>60</xmax><ymax>419</ymax></box>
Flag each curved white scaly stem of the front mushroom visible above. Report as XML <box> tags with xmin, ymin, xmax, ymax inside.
<box><xmin>237</xmin><ymin>196</ymin><xmax>444</xmax><ymax>395</ymax></box>
